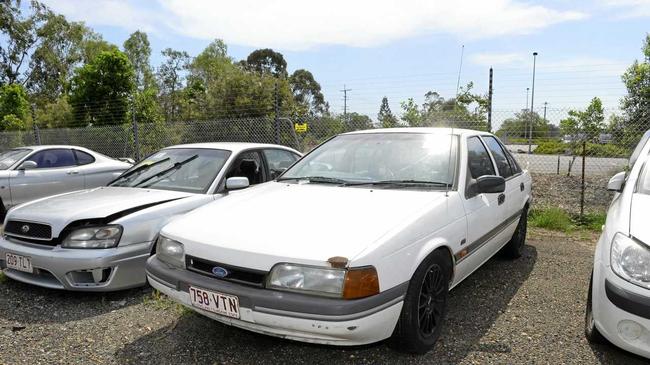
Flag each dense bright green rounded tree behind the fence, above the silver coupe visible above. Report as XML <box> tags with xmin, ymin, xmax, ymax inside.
<box><xmin>70</xmin><ymin>50</ymin><xmax>135</xmax><ymax>126</ymax></box>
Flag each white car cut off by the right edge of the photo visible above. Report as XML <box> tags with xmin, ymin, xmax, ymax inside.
<box><xmin>585</xmin><ymin>131</ymin><xmax>650</xmax><ymax>358</ymax></box>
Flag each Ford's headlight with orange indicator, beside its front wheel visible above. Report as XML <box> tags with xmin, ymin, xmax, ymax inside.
<box><xmin>266</xmin><ymin>263</ymin><xmax>379</xmax><ymax>299</ymax></box>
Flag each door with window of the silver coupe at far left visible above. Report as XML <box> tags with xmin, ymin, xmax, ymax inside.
<box><xmin>9</xmin><ymin>148</ymin><xmax>84</xmax><ymax>205</ymax></box>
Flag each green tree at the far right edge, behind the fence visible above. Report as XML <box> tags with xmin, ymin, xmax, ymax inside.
<box><xmin>619</xmin><ymin>34</ymin><xmax>650</xmax><ymax>146</ymax></box>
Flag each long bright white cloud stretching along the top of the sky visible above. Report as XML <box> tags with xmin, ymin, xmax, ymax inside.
<box><xmin>41</xmin><ymin>0</ymin><xmax>586</xmax><ymax>50</ymax></box>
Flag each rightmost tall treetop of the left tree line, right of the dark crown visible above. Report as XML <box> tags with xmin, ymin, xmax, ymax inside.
<box><xmin>289</xmin><ymin>69</ymin><xmax>327</xmax><ymax>116</ymax></box>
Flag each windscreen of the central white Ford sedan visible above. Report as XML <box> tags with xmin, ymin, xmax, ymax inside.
<box><xmin>281</xmin><ymin>133</ymin><xmax>457</xmax><ymax>186</ymax></box>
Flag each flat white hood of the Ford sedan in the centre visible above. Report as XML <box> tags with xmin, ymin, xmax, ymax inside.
<box><xmin>162</xmin><ymin>182</ymin><xmax>444</xmax><ymax>270</ymax></box>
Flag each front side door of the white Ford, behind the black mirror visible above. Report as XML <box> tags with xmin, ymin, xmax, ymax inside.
<box><xmin>455</xmin><ymin>136</ymin><xmax>506</xmax><ymax>281</ymax></box>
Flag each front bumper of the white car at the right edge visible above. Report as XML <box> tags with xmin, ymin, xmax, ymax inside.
<box><xmin>592</xmin><ymin>262</ymin><xmax>650</xmax><ymax>358</ymax></box>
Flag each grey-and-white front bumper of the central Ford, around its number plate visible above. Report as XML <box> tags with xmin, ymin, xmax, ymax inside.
<box><xmin>146</xmin><ymin>255</ymin><xmax>408</xmax><ymax>346</ymax></box>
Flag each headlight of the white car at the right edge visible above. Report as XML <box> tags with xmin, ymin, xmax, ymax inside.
<box><xmin>610</xmin><ymin>233</ymin><xmax>650</xmax><ymax>289</ymax></box>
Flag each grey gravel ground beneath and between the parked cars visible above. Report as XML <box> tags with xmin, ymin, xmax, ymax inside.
<box><xmin>0</xmin><ymin>230</ymin><xmax>646</xmax><ymax>365</ymax></box>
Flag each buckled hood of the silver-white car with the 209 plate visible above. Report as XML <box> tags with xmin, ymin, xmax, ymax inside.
<box><xmin>7</xmin><ymin>187</ymin><xmax>195</xmax><ymax>236</ymax></box>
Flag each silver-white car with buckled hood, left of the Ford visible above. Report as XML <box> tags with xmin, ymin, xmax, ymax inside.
<box><xmin>0</xmin><ymin>143</ymin><xmax>300</xmax><ymax>291</ymax></box>
